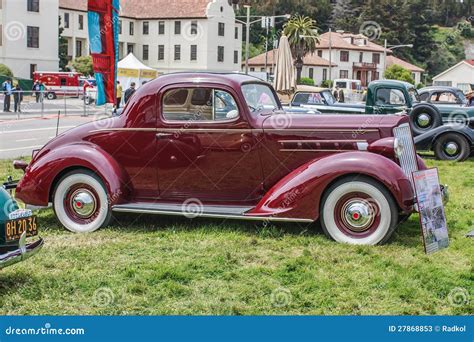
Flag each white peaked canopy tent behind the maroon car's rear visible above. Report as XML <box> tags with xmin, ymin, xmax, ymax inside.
<box><xmin>117</xmin><ymin>53</ymin><xmax>158</xmax><ymax>91</ymax></box>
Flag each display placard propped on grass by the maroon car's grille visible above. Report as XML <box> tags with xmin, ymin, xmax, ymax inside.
<box><xmin>413</xmin><ymin>168</ymin><xmax>449</xmax><ymax>254</ymax></box>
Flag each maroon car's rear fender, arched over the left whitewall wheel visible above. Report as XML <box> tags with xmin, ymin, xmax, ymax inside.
<box><xmin>16</xmin><ymin>143</ymin><xmax>130</xmax><ymax>206</ymax></box>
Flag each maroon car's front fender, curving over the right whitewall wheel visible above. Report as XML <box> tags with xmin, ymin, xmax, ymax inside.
<box><xmin>247</xmin><ymin>152</ymin><xmax>414</xmax><ymax>220</ymax></box>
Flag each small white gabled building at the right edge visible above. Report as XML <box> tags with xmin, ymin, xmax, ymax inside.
<box><xmin>433</xmin><ymin>59</ymin><xmax>474</xmax><ymax>91</ymax></box>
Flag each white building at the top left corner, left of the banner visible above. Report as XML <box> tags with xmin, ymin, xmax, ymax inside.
<box><xmin>0</xmin><ymin>0</ymin><xmax>59</xmax><ymax>78</ymax></box>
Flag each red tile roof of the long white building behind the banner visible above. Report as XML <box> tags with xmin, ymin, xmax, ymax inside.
<box><xmin>59</xmin><ymin>0</ymin><xmax>210</xmax><ymax>19</ymax></box>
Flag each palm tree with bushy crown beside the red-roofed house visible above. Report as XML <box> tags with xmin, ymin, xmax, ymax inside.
<box><xmin>283</xmin><ymin>16</ymin><xmax>319</xmax><ymax>83</ymax></box>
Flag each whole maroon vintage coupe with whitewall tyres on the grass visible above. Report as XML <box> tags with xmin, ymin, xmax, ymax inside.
<box><xmin>16</xmin><ymin>73</ymin><xmax>425</xmax><ymax>244</ymax></box>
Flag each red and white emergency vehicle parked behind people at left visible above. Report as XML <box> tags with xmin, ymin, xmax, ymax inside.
<box><xmin>33</xmin><ymin>71</ymin><xmax>94</xmax><ymax>100</ymax></box>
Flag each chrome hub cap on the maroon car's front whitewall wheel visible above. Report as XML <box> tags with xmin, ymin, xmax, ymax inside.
<box><xmin>342</xmin><ymin>199</ymin><xmax>375</xmax><ymax>232</ymax></box>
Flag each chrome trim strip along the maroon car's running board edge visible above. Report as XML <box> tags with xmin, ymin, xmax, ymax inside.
<box><xmin>112</xmin><ymin>207</ymin><xmax>314</xmax><ymax>222</ymax></box>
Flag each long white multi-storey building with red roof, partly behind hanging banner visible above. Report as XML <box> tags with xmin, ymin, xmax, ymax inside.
<box><xmin>59</xmin><ymin>0</ymin><xmax>242</xmax><ymax>72</ymax></box>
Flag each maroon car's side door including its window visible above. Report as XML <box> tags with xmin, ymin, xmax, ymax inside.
<box><xmin>157</xmin><ymin>84</ymin><xmax>263</xmax><ymax>202</ymax></box>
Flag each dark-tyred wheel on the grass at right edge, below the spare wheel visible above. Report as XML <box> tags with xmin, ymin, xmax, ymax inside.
<box><xmin>433</xmin><ymin>133</ymin><xmax>471</xmax><ymax>161</ymax></box>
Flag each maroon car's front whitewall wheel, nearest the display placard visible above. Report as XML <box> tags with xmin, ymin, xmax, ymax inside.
<box><xmin>320</xmin><ymin>177</ymin><xmax>398</xmax><ymax>245</ymax></box>
